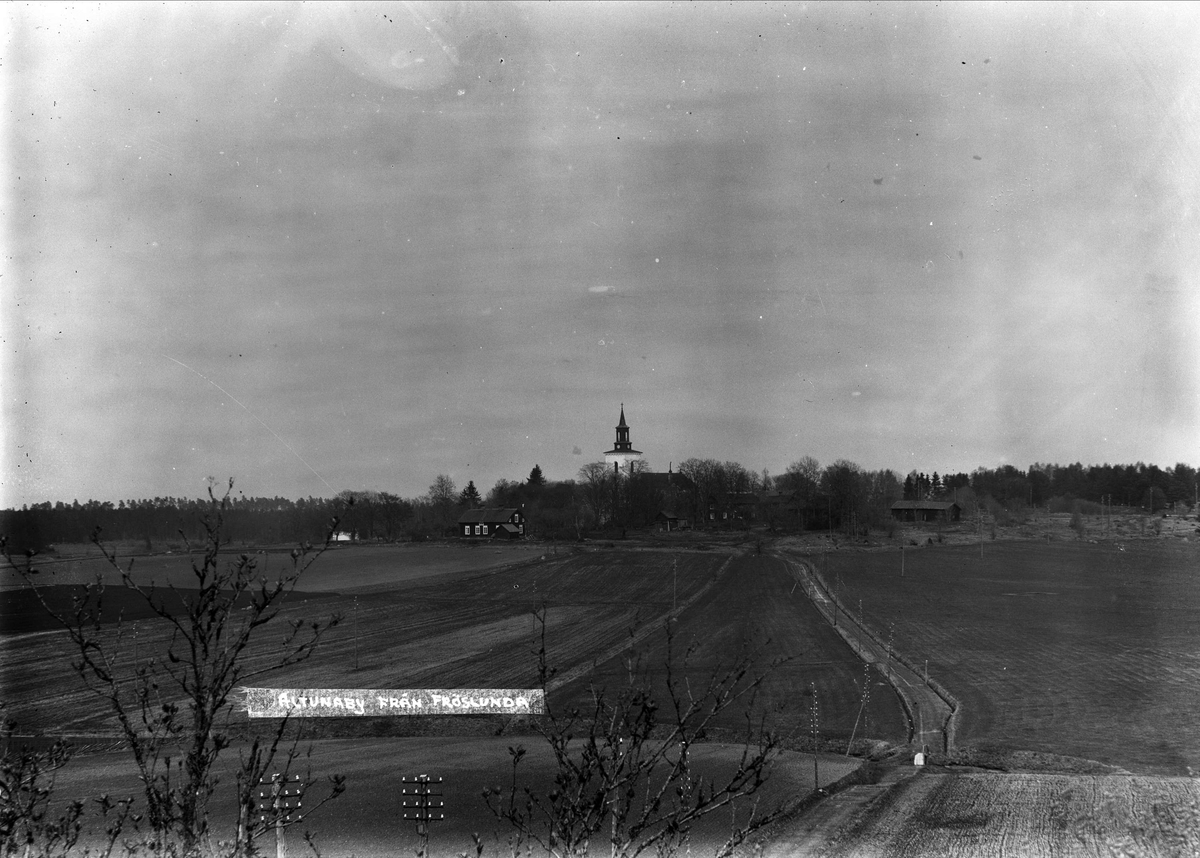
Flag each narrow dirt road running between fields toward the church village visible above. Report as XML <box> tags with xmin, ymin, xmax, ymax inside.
<box><xmin>782</xmin><ymin>557</ymin><xmax>961</xmax><ymax>755</ymax></box>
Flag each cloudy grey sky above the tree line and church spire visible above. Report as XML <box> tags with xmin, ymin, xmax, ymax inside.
<box><xmin>0</xmin><ymin>2</ymin><xmax>1200</xmax><ymax>508</ymax></box>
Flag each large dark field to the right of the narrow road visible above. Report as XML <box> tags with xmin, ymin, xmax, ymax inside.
<box><xmin>812</xmin><ymin>540</ymin><xmax>1200</xmax><ymax>775</ymax></box>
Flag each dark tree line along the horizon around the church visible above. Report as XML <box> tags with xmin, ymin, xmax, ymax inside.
<box><xmin>0</xmin><ymin>456</ymin><xmax>1198</xmax><ymax>552</ymax></box>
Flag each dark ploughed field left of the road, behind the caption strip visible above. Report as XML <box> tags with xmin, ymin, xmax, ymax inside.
<box><xmin>0</xmin><ymin>547</ymin><xmax>906</xmax><ymax>740</ymax></box>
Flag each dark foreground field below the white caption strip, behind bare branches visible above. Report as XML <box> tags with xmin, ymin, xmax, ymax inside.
<box><xmin>42</xmin><ymin>737</ymin><xmax>859</xmax><ymax>858</ymax></box>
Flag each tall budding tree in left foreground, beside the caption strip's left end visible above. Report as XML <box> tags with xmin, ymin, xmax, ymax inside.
<box><xmin>5</xmin><ymin>480</ymin><xmax>343</xmax><ymax>858</ymax></box>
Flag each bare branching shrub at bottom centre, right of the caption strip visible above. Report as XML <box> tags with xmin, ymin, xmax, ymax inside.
<box><xmin>484</xmin><ymin>612</ymin><xmax>781</xmax><ymax>858</ymax></box>
